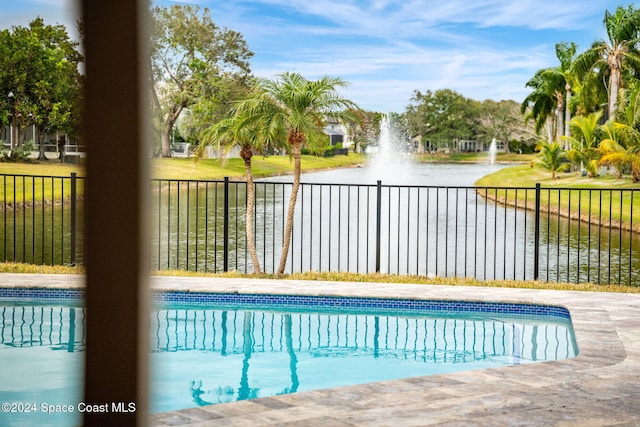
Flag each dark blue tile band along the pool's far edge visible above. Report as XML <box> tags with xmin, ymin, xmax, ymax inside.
<box><xmin>0</xmin><ymin>288</ymin><xmax>571</xmax><ymax>320</ymax></box>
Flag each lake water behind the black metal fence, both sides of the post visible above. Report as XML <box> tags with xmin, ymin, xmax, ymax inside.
<box><xmin>0</xmin><ymin>161</ymin><xmax>640</xmax><ymax>285</ymax></box>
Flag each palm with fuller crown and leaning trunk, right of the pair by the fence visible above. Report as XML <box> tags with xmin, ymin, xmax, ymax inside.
<box><xmin>237</xmin><ymin>72</ymin><xmax>358</xmax><ymax>274</ymax></box>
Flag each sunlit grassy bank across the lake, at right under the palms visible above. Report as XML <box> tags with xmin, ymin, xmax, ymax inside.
<box><xmin>476</xmin><ymin>165</ymin><xmax>640</xmax><ymax>232</ymax></box>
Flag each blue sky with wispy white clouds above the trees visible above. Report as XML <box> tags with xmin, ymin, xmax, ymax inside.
<box><xmin>0</xmin><ymin>0</ymin><xmax>633</xmax><ymax>113</ymax></box>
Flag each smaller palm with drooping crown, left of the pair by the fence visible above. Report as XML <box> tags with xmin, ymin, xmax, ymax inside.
<box><xmin>194</xmin><ymin>115</ymin><xmax>263</xmax><ymax>274</ymax></box>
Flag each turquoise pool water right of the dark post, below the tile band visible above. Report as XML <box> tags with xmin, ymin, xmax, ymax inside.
<box><xmin>151</xmin><ymin>308</ymin><xmax>577</xmax><ymax>411</ymax></box>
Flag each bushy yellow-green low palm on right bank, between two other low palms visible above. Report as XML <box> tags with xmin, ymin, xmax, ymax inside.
<box><xmin>564</xmin><ymin>110</ymin><xmax>602</xmax><ymax>177</ymax></box>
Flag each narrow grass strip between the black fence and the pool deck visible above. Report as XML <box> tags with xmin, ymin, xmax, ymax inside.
<box><xmin>0</xmin><ymin>263</ymin><xmax>640</xmax><ymax>293</ymax></box>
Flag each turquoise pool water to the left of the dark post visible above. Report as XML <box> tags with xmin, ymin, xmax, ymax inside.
<box><xmin>0</xmin><ymin>302</ymin><xmax>86</xmax><ymax>426</ymax></box>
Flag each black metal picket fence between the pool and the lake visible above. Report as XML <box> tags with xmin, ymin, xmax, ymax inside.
<box><xmin>0</xmin><ymin>175</ymin><xmax>640</xmax><ymax>285</ymax></box>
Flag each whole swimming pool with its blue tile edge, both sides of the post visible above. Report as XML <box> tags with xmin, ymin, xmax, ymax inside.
<box><xmin>0</xmin><ymin>289</ymin><xmax>577</xmax><ymax>426</ymax></box>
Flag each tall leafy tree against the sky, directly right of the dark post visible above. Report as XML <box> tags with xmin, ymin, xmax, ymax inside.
<box><xmin>150</xmin><ymin>5</ymin><xmax>253</xmax><ymax>157</ymax></box>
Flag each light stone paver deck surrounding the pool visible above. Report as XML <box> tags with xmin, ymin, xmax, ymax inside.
<box><xmin>0</xmin><ymin>274</ymin><xmax>640</xmax><ymax>427</ymax></box>
